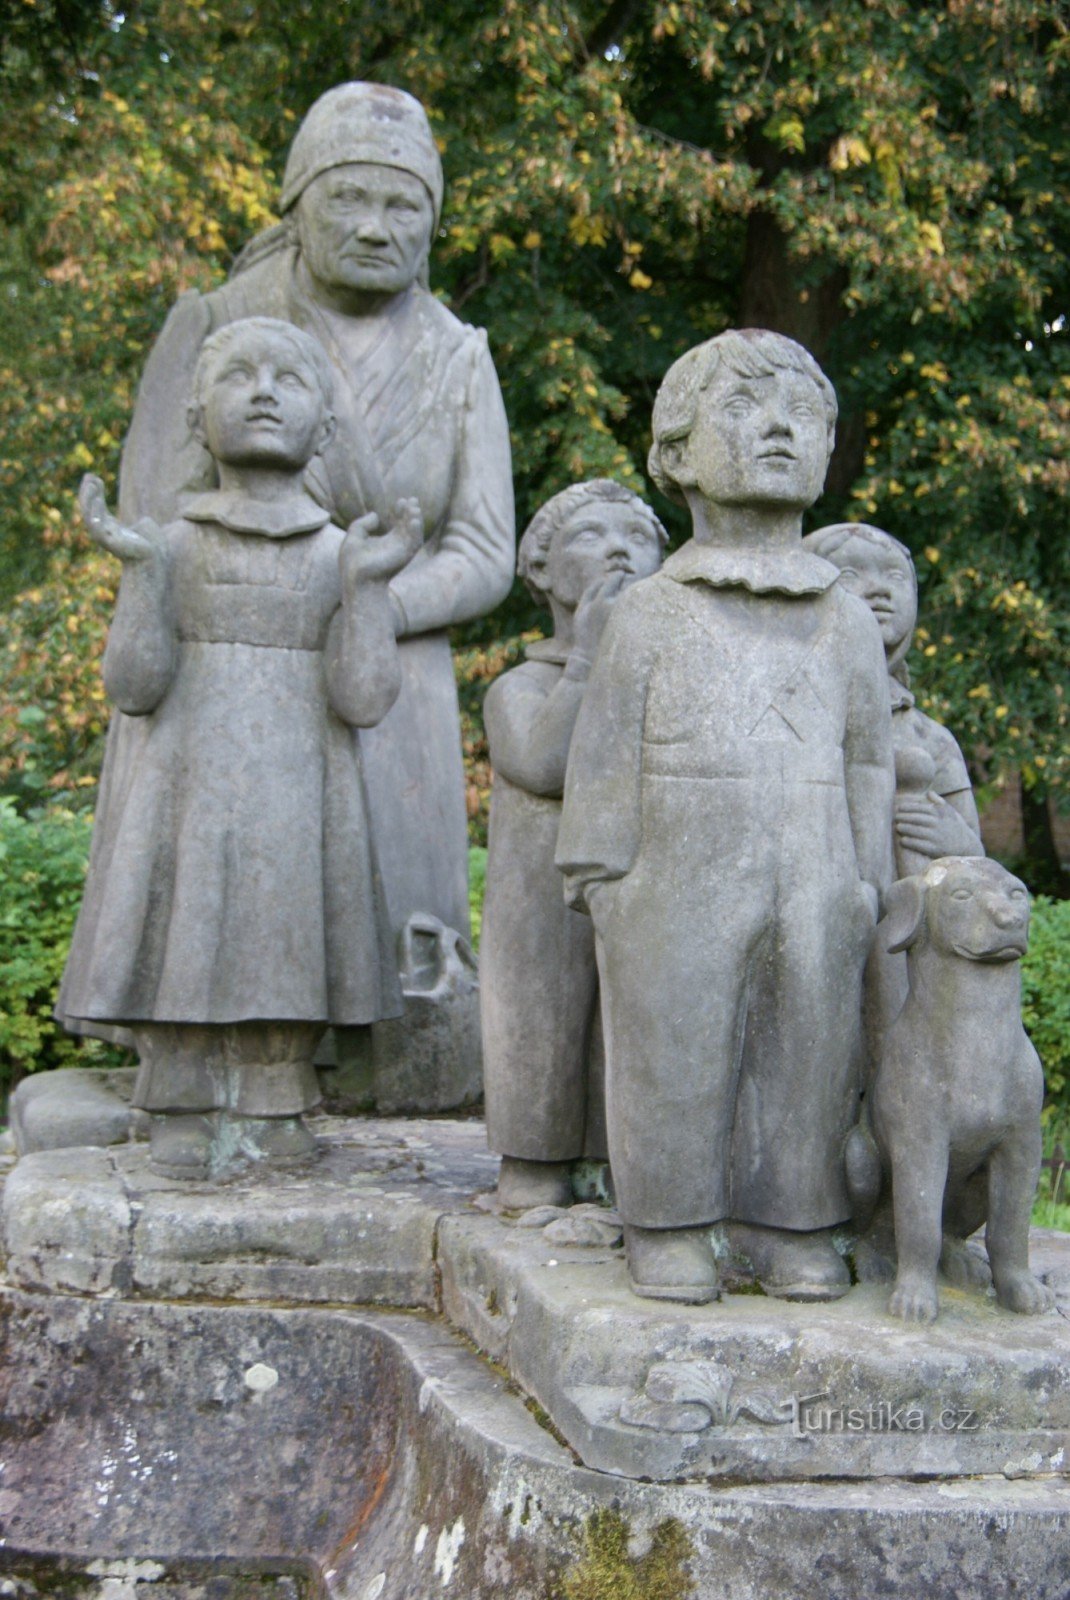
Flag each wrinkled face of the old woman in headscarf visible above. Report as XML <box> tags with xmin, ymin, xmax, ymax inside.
<box><xmin>297</xmin><ymin>162</ymin><xmax>435</xmax><ymax>294</ymax></box>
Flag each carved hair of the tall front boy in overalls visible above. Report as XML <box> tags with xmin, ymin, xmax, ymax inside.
<box><xmin>646</xmin><ymin>328</ymin><xmax>836</xmax><ymax>504</ymax></box>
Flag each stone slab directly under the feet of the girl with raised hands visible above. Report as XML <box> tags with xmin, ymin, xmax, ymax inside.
<box><xmin>2</xmin><ymin>1118</ymin><xmax>496</xmax><ymax>1307</ymax></box>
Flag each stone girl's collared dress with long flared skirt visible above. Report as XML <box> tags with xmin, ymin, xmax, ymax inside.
<box><xmin>58</xmin><ymin>491</ymin><xmax>401</xmax><ymax>1027</ymax></box>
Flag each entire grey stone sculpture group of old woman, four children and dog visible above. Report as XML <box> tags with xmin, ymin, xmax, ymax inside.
<box><xmin>59</xmin><ymin>83</ymin><xmax>1051</xmax><ymax>1320</ymax></box>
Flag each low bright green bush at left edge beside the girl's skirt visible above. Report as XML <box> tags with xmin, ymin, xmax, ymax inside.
<box><xmin>0</xmin><ymin>800</ymin><xmax>126</xmax><ymax>1091</ymax></box>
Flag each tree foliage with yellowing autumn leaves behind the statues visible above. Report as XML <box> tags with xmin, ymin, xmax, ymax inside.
<box><xmin>0</xmin><ymin>0</ymin><xmax>1070</xmax><ymax>864</ymax></box>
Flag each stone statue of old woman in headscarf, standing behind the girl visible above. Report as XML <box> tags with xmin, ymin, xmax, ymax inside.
<box><xmin>112</xmin><ymin>83</ymin><xmax>515</xmax><ymax>1109</ymax></box>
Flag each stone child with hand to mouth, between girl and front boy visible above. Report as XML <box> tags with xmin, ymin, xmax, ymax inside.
<box><xmin>480</xmin><ymin>478</ymin><xmax>667</xmax><ymax>1210</ymax></box>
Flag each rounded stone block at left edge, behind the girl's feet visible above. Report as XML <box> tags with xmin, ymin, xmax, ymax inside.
<box><xmin>8</xmin><ymin>1067</ymin><xmax>139</xmax><ymax>1155</ymax></box>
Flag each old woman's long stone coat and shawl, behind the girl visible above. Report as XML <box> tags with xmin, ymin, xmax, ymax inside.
<box><xmin>112</xmin><ymin>244</ymin><xmax>515</xmax><ymax>933</ymax></box>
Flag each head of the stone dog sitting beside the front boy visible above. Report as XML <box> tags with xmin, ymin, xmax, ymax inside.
<box><xmin>881</xmin><ymin>856</ymin><xmax>1028</xmax><ymax>962</ymax></box>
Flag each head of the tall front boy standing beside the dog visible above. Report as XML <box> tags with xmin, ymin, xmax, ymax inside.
<box><xmin>648</xmin><ymin>328</ymin><xmax>836</xmax><ymax>509</ymax></box>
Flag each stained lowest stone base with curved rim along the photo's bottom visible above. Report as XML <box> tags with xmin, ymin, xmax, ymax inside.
<box><xmin>0</xmin><ymin>1293</ymin><xmax>1070</xmax><ymax>1600</ymax></box>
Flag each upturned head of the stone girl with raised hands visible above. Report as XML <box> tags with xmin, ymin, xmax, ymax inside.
<box><xmin>189</xmin><ymin>317</ymin><xmax>334</xmax><ymax>470</ymax></box>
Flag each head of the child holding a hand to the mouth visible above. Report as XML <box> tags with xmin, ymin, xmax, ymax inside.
<box><xmin>517</xmin><ymin>478</ymin><xmax>669</xmax><ymax>611</ymax></box>
